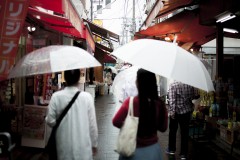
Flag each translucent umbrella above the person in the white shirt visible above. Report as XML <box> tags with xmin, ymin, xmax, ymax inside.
<box><xmin>8</xmin><ymin>45</ymin><xmax>101</xmax><ymax>78</ymax></box>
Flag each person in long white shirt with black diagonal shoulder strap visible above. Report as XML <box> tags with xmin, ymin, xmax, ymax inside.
<box><xmin>46</xmin><ymin>69</ymin><xmax>98</xmax><ymax>160</ymax></box>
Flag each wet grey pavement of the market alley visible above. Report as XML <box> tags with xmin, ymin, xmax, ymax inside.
<box><xmin>7</xmin><ymin>93</ymin><xmax>240</xmax><ymax>160</ymax></box>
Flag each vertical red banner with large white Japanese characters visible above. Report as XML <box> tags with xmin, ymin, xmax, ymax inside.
<box><xmin>0</xmin><ymin>0</ymin><xmax>29</xmax><ymax>81</ymax></box>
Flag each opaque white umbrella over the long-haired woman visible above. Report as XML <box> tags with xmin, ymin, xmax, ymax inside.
<box><xmin>112</xmin><ymin>39</ymin><xmax>214</xmax><ymax>91</ymax></box>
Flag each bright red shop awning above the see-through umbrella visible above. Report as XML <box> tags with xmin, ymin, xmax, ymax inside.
<box><xmin>28</xmin><ymin>0</ymin><xmax>83</xmax><ymax>39</ymax></box>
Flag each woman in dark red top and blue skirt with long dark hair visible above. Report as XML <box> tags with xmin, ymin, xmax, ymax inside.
<box><xmin>112</xmin><ymin>69</ymin><xmax>168</xmax><ymax>160</ymax></box>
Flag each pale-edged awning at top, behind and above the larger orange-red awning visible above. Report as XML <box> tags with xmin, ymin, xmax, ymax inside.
<box><xmin>142</xmin><ymin>0</ymin><xmax>194</xmax><ymax>28</ymax></box>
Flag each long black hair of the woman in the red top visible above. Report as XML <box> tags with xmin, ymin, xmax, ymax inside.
<box><xmin>137</xmin><ymin>69</ymin><xmax>159</xmax><ymax>137</ymax></box>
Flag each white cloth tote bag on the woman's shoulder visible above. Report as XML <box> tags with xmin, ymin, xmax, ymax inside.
<box><xmin>116</xmin><ymin>97</ymin><xmax>138</xmax><ymax>157</ymax></box>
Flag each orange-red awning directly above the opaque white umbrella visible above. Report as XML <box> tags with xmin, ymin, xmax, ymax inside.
<box><xmin>135</xmin><ymin>10</ymin><xmax>216</xmax><ymax>45</ymax></box>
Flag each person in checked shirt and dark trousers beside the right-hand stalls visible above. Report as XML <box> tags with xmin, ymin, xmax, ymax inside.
<box><xmin>166</xmin><ymin>81</ymin><xmax>199</xmax><ymax>159</ymax></box>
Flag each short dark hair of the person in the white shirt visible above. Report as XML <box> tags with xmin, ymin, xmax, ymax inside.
<box><xmin>64</xmin><ymin>69</ymin><xmax>80</xmax><ymax>86</ymax></box>
